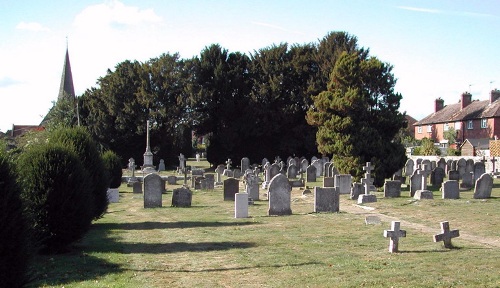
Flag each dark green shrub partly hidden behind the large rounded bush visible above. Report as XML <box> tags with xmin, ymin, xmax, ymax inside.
<box><xmin>49</xmin><ymin>127</ymin><xmax>109</xmax><ymax>219</ymax></box>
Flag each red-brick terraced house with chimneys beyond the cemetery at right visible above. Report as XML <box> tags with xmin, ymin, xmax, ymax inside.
<box><xmin>413</xmin><ymin>89</ymin><xmax>500</xmax><ymax>144</ymax></box>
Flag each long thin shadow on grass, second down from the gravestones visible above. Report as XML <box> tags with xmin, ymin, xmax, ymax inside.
<box><xmin>86</xmin><ymin>241</ymin><xmax>257</xmax><ymax>254</ymax></box>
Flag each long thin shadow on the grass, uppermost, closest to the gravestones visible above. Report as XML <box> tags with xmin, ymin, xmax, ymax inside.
<box><xmin>91</xmin><ymin>221</ymin><xmax>260</xmax><ymax>230</ymax></box>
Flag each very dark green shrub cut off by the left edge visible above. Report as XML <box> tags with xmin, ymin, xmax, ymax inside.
<box><xmin>0</xmin><ymin>147</ymin><xmax>30</xmax><ymax>287</ymax></box>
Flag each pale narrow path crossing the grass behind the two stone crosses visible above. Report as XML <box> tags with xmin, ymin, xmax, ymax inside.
<box><xmin>341</xmin><ymin>205</ymin><xmax>500</xmax><ymax>248</ymax></box>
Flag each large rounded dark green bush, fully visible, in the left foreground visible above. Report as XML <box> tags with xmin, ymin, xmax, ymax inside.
<box><xmin>18</xmin><ymin>144</ymin><xmax>93</xmax><ymax>252</ymax></box>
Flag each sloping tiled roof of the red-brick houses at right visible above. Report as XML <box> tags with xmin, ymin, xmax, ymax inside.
<box><xmin>413</xmin><ymin>99</ymin><xmax>500</xmax><ymax>126</ymax></box>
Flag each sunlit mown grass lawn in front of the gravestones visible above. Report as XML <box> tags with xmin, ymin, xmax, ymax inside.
<box><xmin>28</xmin><ymin>161</ymin><xmax>500</xmax><ymax>287</ymax></box>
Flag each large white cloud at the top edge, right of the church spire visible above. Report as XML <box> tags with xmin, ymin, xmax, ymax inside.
<box><xmin>74</xmin><ymin>0</ymin><xmax>162</xmax><ymax>30</ymax></box>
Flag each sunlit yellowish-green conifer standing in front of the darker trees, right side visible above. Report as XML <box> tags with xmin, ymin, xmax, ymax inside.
<box><xmin>307</xmin><ymin>51</ymin><xmax>406</xmax><ymax>186</ymax></box>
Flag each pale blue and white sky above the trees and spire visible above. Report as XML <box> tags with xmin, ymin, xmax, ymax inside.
<box><xmin>0</xmin><ymin>0</ymin><xmax>500</xmax><ymax>132</ymax></box>
